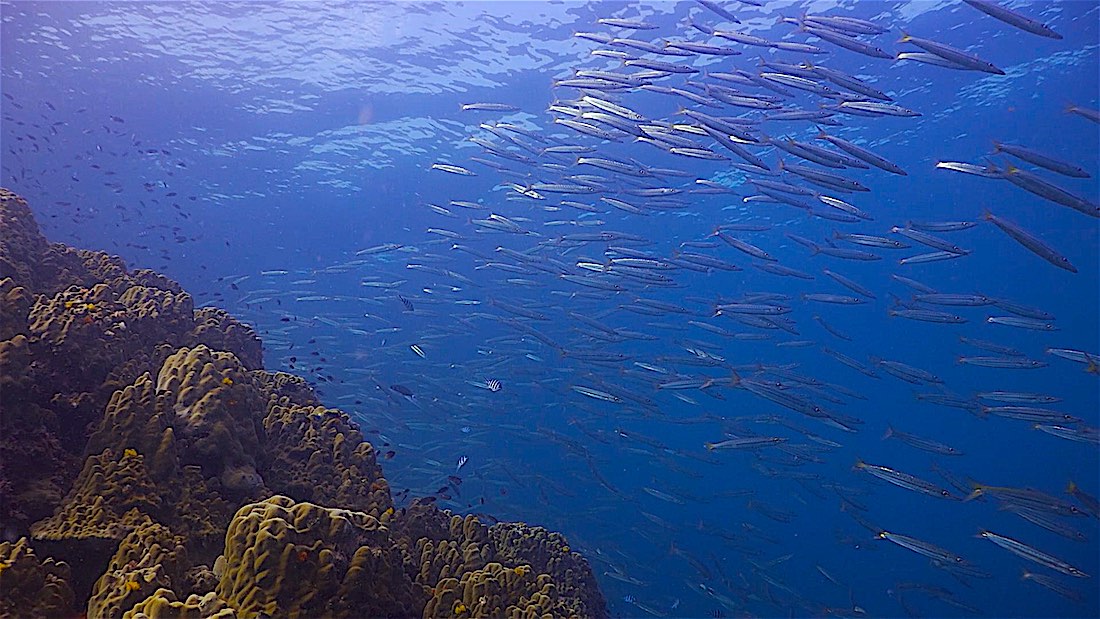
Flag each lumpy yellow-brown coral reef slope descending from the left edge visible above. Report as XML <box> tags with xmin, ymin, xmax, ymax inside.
<box><xmin>0</xmin><ymin>189</ymin><xmax>607</xmax><ymax>619</ymax></box>
